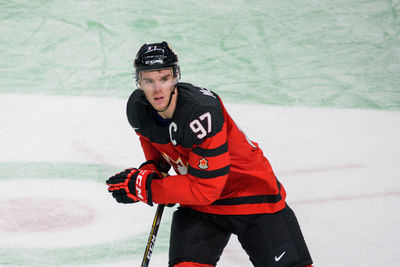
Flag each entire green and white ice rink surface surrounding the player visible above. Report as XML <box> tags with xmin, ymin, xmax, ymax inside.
<box><xmin>0</xmin><ymin>0</ymin><xmax>400</xmax><ymax>267</ymax></box>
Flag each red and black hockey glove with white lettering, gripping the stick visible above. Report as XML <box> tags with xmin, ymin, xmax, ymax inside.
<box><xmin>106</xmin><ymin>168</ymin><xmax>162</xmax><ymax>206</ymax></box>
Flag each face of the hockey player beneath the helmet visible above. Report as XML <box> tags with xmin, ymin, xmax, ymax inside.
<box><xmin>139</xmin><ymin>69</ymin><xmax>176</xmax><ymax>110</ymax></box>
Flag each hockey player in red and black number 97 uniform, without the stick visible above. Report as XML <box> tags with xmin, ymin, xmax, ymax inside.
<box><xmin>107</xmin><ymin>42</ymin><xmax>312</xmax><ymax>267</ymax></box>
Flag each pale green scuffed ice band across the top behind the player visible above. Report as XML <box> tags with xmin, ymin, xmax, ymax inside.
<box><xmin>0</xmin><ymin>0</ymin><xmax>400</xmax><ymax>110</ymax></box>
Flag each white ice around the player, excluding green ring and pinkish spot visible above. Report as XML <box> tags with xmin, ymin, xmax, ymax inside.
<box><xmin>0</xmin><ymin>94</ymin><xmax>400</xmax><ymax>267</ymax></box>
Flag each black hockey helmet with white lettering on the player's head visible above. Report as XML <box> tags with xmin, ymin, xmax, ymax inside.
<box><xmin>134</xmin><ymin>41</ymin><xmax>181</xmax><ymax>81</ymax></box>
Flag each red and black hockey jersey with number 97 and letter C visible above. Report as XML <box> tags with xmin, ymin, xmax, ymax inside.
<box><xmin>127</xmin><ymin>83</ymin><xmax>286</xmax><ymax>215</ymax></box>
